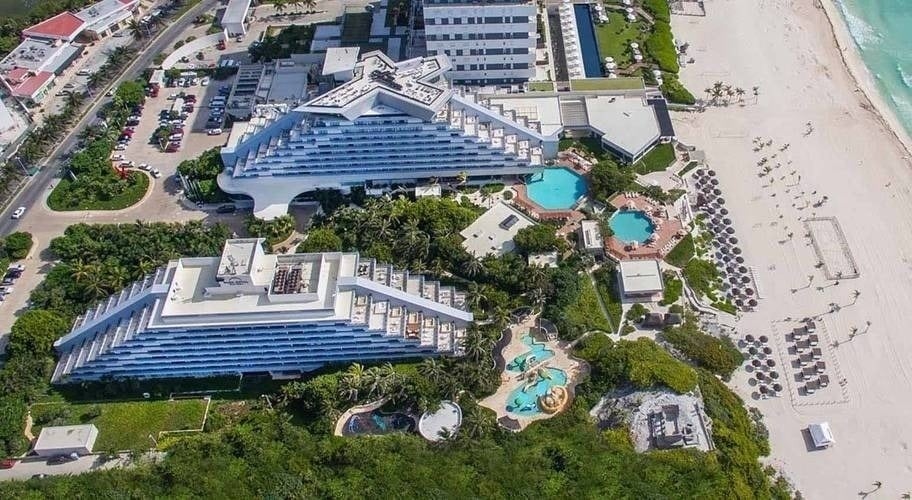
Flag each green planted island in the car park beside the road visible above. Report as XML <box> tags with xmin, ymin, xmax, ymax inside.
<box><xmin>47</xmin><ymin>172</ymin><xmax>149</xmax><ymax>212</ymax></box>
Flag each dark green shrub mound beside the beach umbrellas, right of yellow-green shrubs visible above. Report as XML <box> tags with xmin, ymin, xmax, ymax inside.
<box><xmin>661</xmin><ymin>317</ymin><xmax>744</xmax><ymax>380</ymax></box>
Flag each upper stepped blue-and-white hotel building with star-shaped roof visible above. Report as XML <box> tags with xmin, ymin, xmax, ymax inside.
<box><xmin>218</xmin><ymin>51</ymin><xmax>558</xmax><ymax>219</ymax></box>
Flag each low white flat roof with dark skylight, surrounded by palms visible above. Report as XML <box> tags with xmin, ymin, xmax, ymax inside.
<box><xmin>459</xmin><ymin>202</ymin><xmax>535</xmax><ymax>258</ymax></box>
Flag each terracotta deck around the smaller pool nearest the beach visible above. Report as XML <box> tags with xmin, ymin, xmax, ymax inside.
<box><xmin>605</xmin><ymin>193</ymin><xmax>686</xmax><ymax>260</ymax></box>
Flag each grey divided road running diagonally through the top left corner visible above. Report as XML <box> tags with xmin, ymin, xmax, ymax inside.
<box><xmin>0</xmin><ymin>0</ymin><xmax>218</xmax><ymax>236</ymax></box>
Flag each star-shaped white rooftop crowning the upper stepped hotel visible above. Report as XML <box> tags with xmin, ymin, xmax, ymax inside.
<box><xmin>299</xmin><ymin>51</ymin><xmax>452</xmax><ymax>120</ymax></box>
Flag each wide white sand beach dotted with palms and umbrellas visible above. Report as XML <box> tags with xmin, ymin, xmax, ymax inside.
<box><xmin>673</xmin><ymin>0</ymin><xmax>912</xmax><ymax>498</ymax></box>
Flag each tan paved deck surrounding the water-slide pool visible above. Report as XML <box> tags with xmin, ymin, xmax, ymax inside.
<box><xmin>478</xmin><ymin>315</ymin><xmax>588</xmax><ymax>431</ymax></box>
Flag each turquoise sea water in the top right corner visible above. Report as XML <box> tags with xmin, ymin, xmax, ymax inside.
<box><xmin>836</xmin><ymin>0</ymin><xmax>912</xmax><ymax>135</ymax></box>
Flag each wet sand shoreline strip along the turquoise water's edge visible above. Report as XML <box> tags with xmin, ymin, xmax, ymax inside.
<box><xmin>814</xmin><ymin>0</ymin><xmax>912</xmax><ymax>158</ymax></box>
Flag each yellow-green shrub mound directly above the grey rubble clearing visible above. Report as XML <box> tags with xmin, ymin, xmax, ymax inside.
<box><xmin>575</xmin><ymin>335</ymin><xmax>697</xmax><ymax>398</ymax></box>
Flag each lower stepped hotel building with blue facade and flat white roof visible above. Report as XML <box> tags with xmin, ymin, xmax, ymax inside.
<box><xmin>52</xmin><ymin>238</ymin><xmax>472</xmax><ymax>383</ymax></box>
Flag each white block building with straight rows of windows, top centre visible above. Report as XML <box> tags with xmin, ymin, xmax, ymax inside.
<box><xmin>424</xmin><ymin>0</ymin><xmax>538</xmax><ymax>85</ymax></box>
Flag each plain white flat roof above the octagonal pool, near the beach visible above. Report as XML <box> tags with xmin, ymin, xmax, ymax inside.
<box><xmin>586</xmin><ymin>96</ymin><xmax>659</xmax><ymax>156</ymax></box>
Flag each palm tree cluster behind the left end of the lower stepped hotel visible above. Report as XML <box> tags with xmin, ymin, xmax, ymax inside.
<box><xmin>31</xmin><ymin>221</ymin><xmax>230</xmax><ymax>317</ymax></box>
